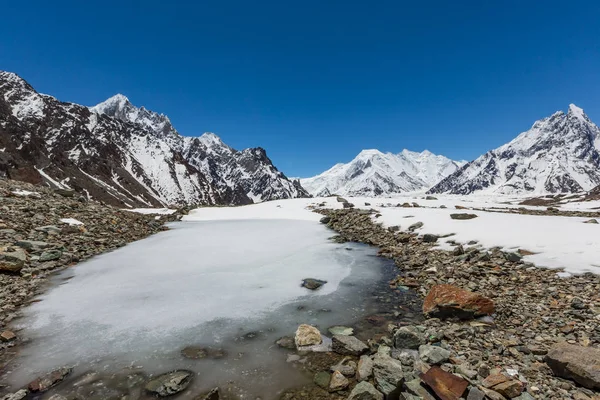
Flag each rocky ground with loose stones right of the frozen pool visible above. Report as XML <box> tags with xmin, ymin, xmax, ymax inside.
<box><xmin>282</xmin><ymin>207</ymin><xmax>600</xmax><ymax>400</ymax></box>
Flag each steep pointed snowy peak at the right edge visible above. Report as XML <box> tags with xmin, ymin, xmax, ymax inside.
<box><xmin>429</xmin><ymin>104</ymin><xmax>600</xmax><ymax>195</ymax></box>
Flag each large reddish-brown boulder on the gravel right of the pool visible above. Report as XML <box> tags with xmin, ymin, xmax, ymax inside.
<box><xmin>423</xmin><ymin>285</ymin><xmax>494</xmax><ymax>319</ymax></box>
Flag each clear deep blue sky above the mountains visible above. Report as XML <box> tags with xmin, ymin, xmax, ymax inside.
<box><xmin>0</xmin><ymin>0</ymin><xmax>600</xmax><ymax>176</ymax></box>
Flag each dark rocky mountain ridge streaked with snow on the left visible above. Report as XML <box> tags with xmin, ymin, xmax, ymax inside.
<box><xmin>0</xmin><ymin>72</ymin><xmax>308</xmax><ymax>207</ymax></box>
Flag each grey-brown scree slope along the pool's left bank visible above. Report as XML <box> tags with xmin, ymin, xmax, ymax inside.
<box><xmin>0</xmin><ymin>179</ymin><xmax>181</xmax><ymax>390</ymax></box>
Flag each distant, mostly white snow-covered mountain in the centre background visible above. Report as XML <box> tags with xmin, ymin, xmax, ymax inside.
<box><xmin>300</xmin><ymin>150</ymin><xmax>464</xmax><ymax>196</ymax></box>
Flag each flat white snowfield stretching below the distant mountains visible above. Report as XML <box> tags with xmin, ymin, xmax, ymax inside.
<box><xmin>190</xmin><ymin>193</ymin><xmax>600</xmax><ymax>274</ymax></box>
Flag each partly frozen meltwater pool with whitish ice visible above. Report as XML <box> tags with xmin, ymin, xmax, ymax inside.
<box><xmin>2</xmin><ymin>220</ymin><xmax>412</xmax><ymax>400</ymax></box>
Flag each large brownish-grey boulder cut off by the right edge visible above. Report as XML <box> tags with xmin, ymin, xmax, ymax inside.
<box><xmin>546</xmin><ymin>342</ymin><xmax>600</xmax><ymax>389</ymax></box>
